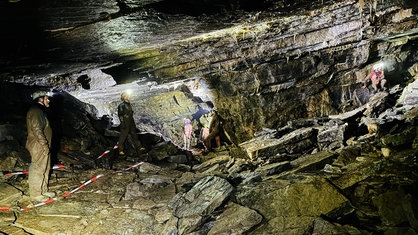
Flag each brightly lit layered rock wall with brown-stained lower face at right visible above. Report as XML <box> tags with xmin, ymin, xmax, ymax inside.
<box><xmin>125</xmin><ymin>1</ymin><xmax>416</xmax><ymax>142</ymax></box>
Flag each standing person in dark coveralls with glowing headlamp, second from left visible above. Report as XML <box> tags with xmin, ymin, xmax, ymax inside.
<box><xmin>118</xmin><ymin>91</ymin><xmax>145</xmax><ymax>156</ymax></box>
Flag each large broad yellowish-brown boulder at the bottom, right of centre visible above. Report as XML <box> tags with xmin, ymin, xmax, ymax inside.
<box><xmin>236</xmin><ymin>175</ymin><xmax>352</xmax><ymax>234</ymax></box>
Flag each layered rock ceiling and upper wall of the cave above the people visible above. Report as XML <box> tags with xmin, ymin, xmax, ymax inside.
<box><xmin>0</xmin><ymin>0</ymin><xmax>418</xmax><ymax>142</ymax></box>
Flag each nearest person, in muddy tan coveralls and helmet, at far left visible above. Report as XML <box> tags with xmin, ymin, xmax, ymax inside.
<box><xmin>26</xmin><ymin>91</ymin><xmax>55</xmax><ymax>201</ymax></box>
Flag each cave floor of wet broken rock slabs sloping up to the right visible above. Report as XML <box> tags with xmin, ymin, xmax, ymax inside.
<box><xmin>0</xmin><ymin>82</ymin><xmax>418</xmax><ymax>234</ymax></box>
